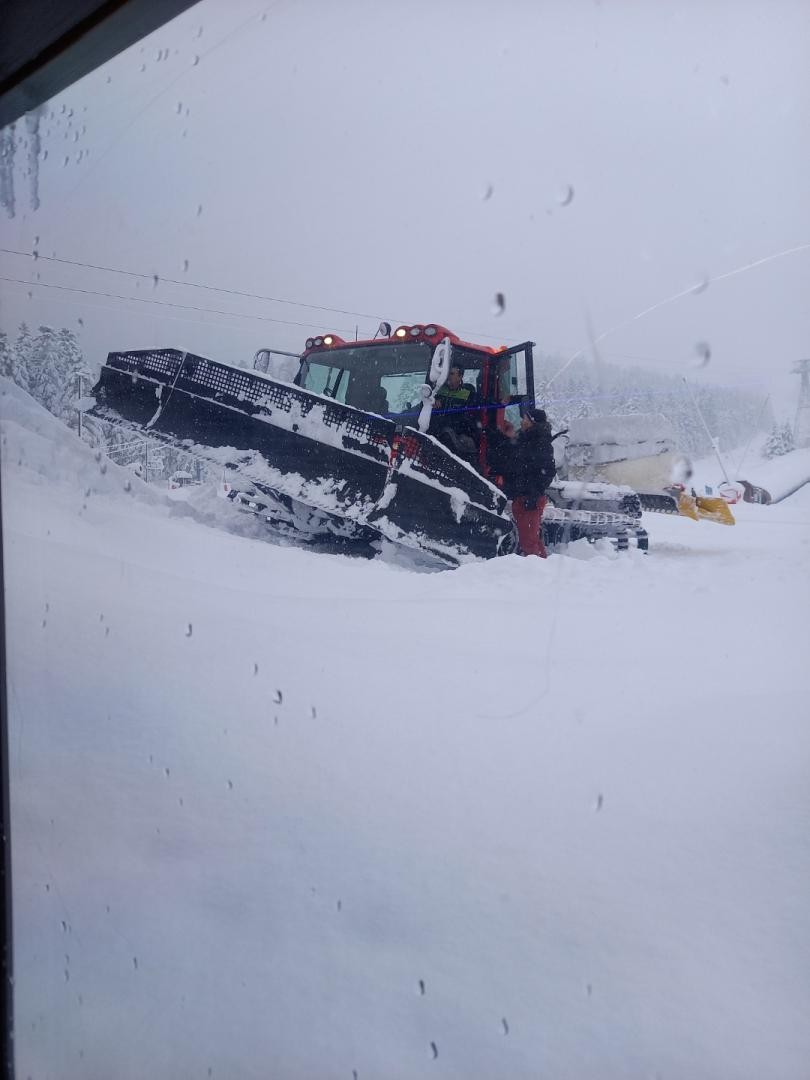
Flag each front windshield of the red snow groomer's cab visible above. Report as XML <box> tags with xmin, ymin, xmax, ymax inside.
<box><xmin>299</xmin><ymin>342</ymin><xmax>433</xmax><ymax>416</ymax></box>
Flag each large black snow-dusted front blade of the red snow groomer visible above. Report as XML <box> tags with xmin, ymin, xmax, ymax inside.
<box><xmin>89</xmin><ymin>349</ymin><xmax>516</xmax><ymax>566</ymax></box>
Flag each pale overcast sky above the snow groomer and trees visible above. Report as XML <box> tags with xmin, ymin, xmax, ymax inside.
<box><xmin>0</xmin><ymin>0</ymin><xmax>810</xmax><ymax>416</ymax></box>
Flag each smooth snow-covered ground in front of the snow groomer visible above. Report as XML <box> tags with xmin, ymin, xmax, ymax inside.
<box><xmin>0</xmin><ymin>383</ymin><xmax>810</xmax><ymax>1080</ymax></box>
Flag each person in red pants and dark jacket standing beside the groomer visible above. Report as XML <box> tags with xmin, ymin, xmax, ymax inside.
<box><xmin>491</xmin><ymin>406</ymin><xmax>556</xmax><ymax>558</ymax></box>
